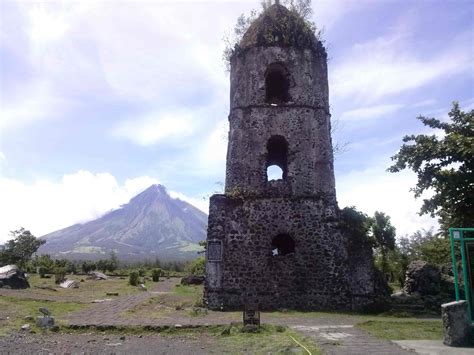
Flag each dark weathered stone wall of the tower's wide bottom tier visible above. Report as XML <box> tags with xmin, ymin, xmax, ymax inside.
<box><xmin>205</xmin><ymin>195</ymin><xmax>379</xmax><ymax>310</ymax></box>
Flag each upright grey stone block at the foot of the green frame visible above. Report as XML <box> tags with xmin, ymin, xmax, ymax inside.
<box><xmin>441</xmin><ymin>301</ymin><xmax>471</xmax><ymax>346</ymax></box>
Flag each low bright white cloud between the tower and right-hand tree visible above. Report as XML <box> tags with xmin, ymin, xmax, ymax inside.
<box><xmin>337</xmin><ymin>162</ymin><xmax>437</xmax><ymax>237</ymax></box>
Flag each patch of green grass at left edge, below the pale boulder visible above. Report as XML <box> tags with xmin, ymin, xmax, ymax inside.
<box><xmin>0</xmin><ymin>296</ymin><xmax>87</xmax><ymax>336</ymax></box>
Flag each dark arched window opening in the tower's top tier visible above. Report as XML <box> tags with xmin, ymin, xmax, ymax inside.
<box><xmin>265</xmin><ymin>63</ymin><xmax>290</xmax><ymax>104</ymax></box>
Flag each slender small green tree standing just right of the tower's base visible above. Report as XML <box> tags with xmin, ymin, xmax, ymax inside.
<box><xmin>371</xmin><ymin>211</ymin><xmax>396</xmax><ymax>274</ymax></box>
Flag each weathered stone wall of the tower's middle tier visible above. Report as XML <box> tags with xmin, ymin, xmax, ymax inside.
<box><xmin>226</xmin><ymin>107</ymin><xmax>335</xmax><ymax>198</ymax></box>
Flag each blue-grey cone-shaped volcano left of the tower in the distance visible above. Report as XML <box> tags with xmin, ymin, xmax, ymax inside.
<box><xmin>38</xmin><ymin>185</ymin><xmax>207</xmax><ymax>260</ymax></box>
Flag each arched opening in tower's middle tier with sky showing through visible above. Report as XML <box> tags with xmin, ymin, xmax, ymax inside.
<box><xmin>267</xmin><ymin>136</ymin><xmax>288</xmax><ymax>181</ymax></box>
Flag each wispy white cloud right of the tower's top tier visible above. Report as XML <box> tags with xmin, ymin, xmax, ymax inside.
<box><xmin>330</xmin><ymin>34</ymin><xmax>472</xmax><ymax>103</ymax></box>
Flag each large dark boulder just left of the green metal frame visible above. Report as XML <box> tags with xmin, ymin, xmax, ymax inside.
<box><xmin>404</xmin><ymin>260</ymin><xmax>441</xmax><ymax>296</ymax></box>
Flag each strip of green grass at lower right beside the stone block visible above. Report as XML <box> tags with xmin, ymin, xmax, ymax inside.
<box><xmin>356</xmin><ymin>318</ymin><xmax>443</xmax><ymax>340</ymax></box>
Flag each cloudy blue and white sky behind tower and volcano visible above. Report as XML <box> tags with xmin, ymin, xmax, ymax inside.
<box><xmin>0</xmin><ymin>0</ymin><xmax>474</xmax><ymax>242</ymax></box>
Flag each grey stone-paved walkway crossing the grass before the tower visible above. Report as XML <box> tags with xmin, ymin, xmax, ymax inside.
<box><xmin>66</xmin><ymin>279</ymin><xmax>414</xmax><ymax>355</ymax></box>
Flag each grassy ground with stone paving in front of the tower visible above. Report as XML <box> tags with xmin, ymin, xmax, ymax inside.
<box><xmin>0</xmin><ymin>276</ymin><xmax>460</xmax><ymax>354</ymax></box>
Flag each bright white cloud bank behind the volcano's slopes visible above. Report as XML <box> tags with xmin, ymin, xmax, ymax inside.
<box><xmin>0</xmin><ymin>170</ymin><xmax>207</xmax><ymax>243</ymax></box>
